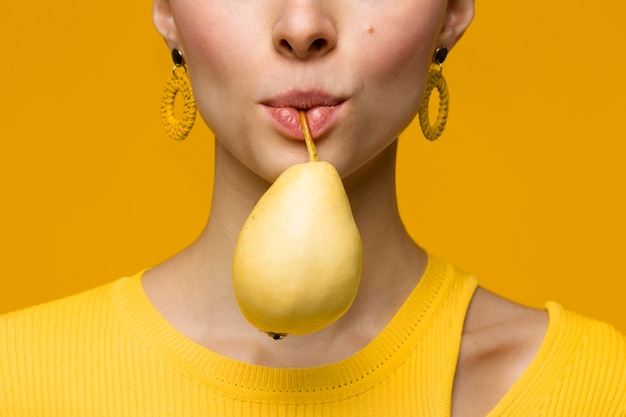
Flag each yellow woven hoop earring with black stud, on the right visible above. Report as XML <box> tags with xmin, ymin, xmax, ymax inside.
<box><xmin>418</xmin><ymin>46</ymin><xmax>450</xmax><ymax>141</ymax></box>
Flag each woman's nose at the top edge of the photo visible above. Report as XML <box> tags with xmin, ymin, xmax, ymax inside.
<box><xmin>272</xmin><ymin>0</ymin><xmax>334</xmax><ymax>59</ymax></box>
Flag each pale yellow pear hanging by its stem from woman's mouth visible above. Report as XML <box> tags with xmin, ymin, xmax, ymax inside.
<box><xmin>232</xmin><ymin>112</ymin><xmax>362</xmax><ymax>339</ymax></box>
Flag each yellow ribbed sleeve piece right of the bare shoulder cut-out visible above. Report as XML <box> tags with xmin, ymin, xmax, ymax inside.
<box><xmin>488</xmin><ymin>302</ymin><xmax>626</xmax><ymax>417</ymax></box>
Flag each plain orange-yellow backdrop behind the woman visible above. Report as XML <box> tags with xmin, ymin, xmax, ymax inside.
<box><xmin>0</xmin><ymin>0</ymin><xmax>626</xmax><ymax>331</ymax></box>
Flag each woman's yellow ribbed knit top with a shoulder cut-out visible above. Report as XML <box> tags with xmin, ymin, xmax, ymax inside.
<box><xmin>0</xmin><ymin>256</ymin><xmax>626</xmax><ymax>417</ymax></box>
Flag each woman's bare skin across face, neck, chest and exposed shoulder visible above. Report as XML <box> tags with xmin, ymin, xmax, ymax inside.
<box><xmin>143</xmin><ymin>0</ymin><xmax>547</xmax><ymax>417</ymax></box>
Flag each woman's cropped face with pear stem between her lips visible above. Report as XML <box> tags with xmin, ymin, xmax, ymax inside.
<box><xmin>155</xmin><ymin>0</ymin><xmax>471</xmax><ymax>180</ymax></box>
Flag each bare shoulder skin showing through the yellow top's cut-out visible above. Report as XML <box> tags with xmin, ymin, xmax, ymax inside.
<box><xmin>452</xmin><ymin>288</ymin><xmax>548</xmax><ymax>417</ymax></box>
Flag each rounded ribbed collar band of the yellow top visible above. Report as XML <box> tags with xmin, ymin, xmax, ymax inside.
<box><xmin>110</xmin><ymin>255</ymin><xmax>452</xmax><ymax>402</ymax></box>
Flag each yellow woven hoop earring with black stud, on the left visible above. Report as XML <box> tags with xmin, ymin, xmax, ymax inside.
<box><xmin>161</xmin><ymin>49</ymin><xmax>197</xmax><ymax>140</ymax></box>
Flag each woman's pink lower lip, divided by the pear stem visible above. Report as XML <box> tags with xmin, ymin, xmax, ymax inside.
<box><xmin>266</xmin><ymin>103</ymin><xmax>343</xmax><ymax>140</ymax></box>
